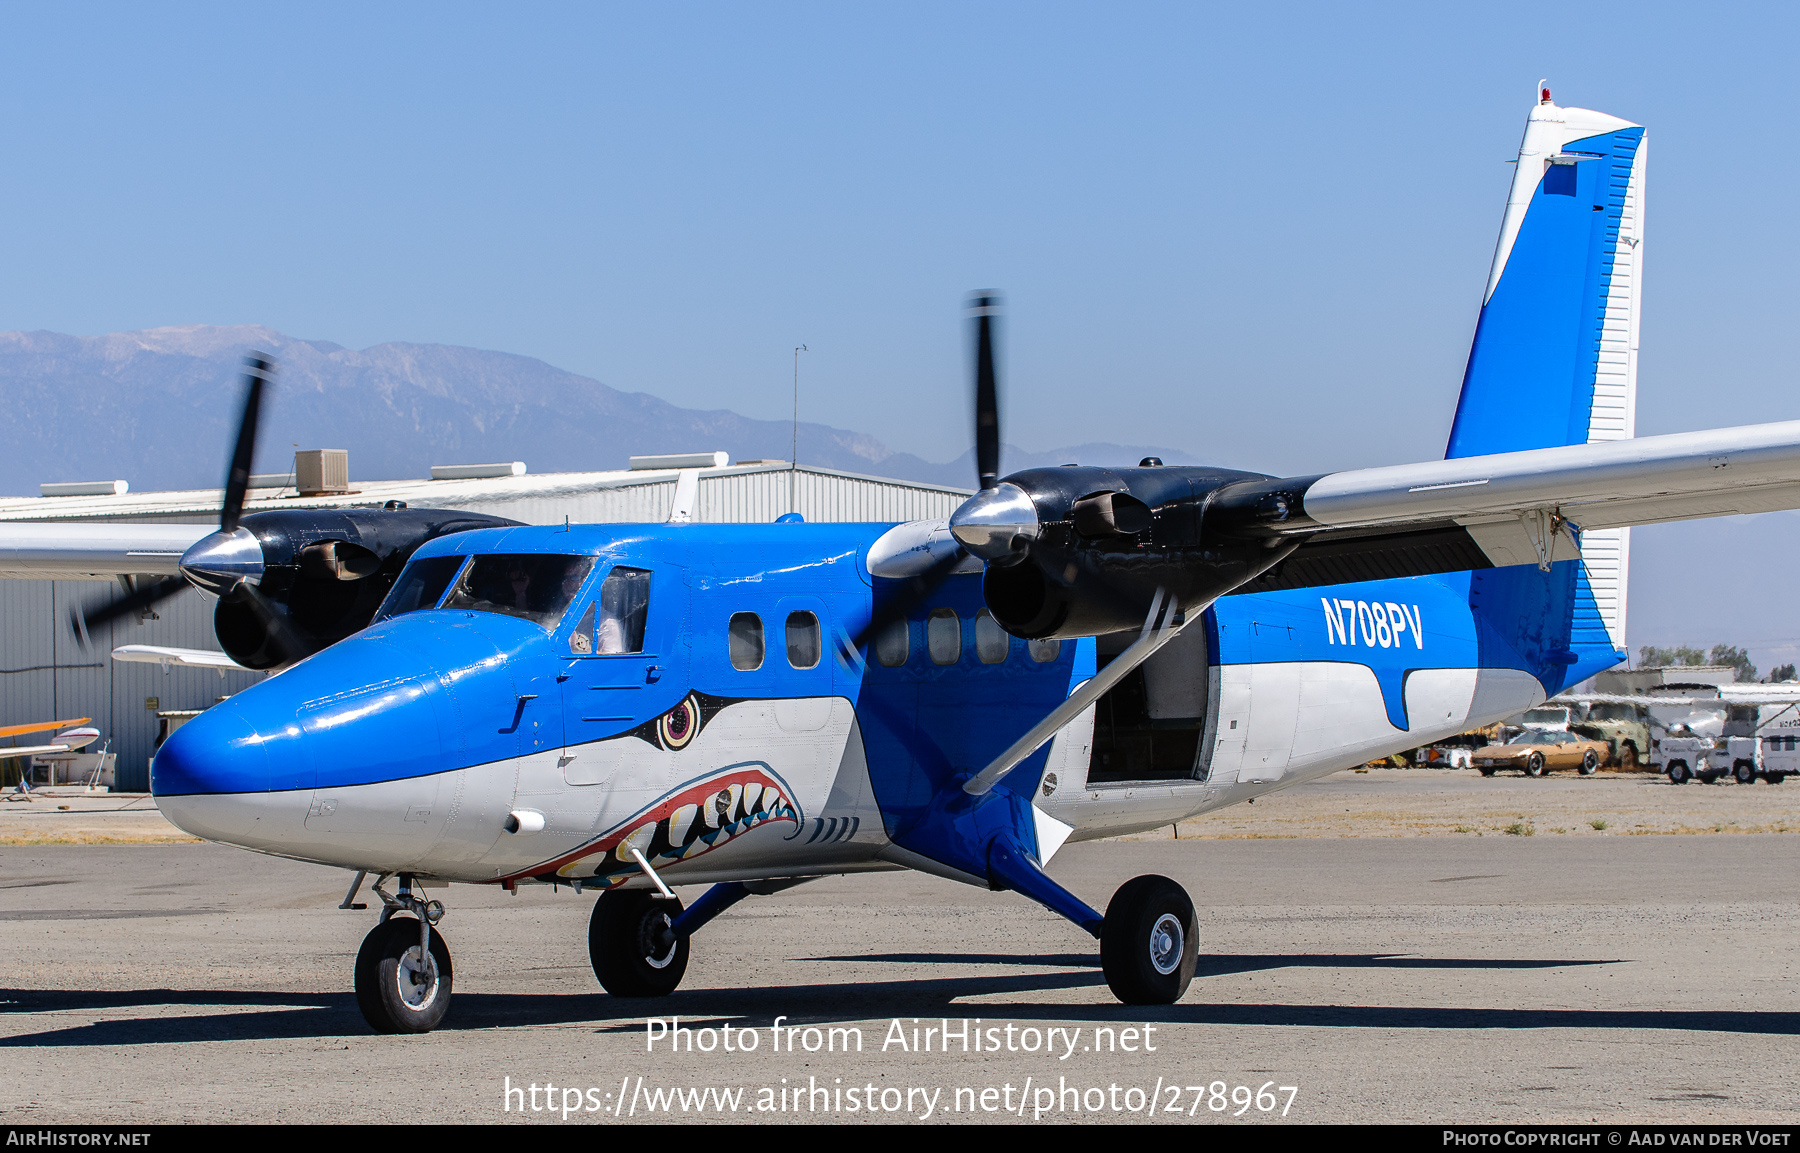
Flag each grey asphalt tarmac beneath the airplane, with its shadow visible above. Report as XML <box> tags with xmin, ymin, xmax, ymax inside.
<box><xmin>0</xmin><ymin>820</ymin><xmax>1800</xmax><ymax>1124</ymax></box>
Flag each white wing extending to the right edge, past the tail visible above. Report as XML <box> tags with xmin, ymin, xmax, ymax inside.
<box><xmin>1231</xmin><ymin>421</ymin><xmax>1800</xmax><ymax>592</ymax></box>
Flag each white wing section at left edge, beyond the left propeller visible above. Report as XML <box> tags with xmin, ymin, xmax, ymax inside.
<box><xmin>0</xmin><ymin>522</ymin><xmax>218</xmax><ymax>581</ymax></box>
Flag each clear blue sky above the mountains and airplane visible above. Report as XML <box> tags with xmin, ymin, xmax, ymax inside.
<box><xmin>0</xmin><ymin>4</ymin><xmax>1800</xmax><ymax>665</ymax></box>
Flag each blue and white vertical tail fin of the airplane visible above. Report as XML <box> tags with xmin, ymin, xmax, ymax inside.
<box><xmin>1445</xmin><ymin>88</ymin><xmax>1645</xmax><ymax>648</ymax></box>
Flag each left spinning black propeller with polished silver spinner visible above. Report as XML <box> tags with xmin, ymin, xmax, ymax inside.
<box><xmin>68</xmin><ymin>353</ymin><xmax>306</xmax><ymax>660</ymax></box>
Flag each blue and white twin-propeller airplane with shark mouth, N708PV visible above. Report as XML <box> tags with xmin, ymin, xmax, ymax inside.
<box><xmin>10</xmin><ymin>88</ymin><xmax>1800</xmax><ymax>1032</ymax></box>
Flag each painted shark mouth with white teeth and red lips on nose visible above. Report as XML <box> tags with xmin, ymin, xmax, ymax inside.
<box><xmin>527</xmin><ymin>766</ymin><xmax>803</xmax><ymax>889</ymax></box>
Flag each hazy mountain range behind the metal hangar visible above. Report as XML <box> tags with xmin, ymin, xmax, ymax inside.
<box><xmin>0</xmin><ymin>326</ymin><xmax>1195</xmax><ymax>496</ymax></box>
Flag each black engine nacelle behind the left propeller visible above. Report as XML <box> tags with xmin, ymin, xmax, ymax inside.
<box><xmin>212</xmin><ymin>507</ymin><xmax>518</xmax><ymax>669</ymax></box>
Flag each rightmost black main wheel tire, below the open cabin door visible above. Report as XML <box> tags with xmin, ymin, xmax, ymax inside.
<box><xmin>1100</xmin><ymin>874</ymin><xmax>1201</xmax><ymax>1006</ymax></box>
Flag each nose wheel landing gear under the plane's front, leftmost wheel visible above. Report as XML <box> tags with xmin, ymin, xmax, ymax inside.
<box><xmin>356</xmin><ymin>874</ymin><xmax>452</xmax><ymax>1032</ymax></box>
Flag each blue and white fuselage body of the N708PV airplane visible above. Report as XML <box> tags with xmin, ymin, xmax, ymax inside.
<box><xmin>151</xmin><ymin>523</ymin><xmax>1618</xmax><ymax>880</ymax></box>
